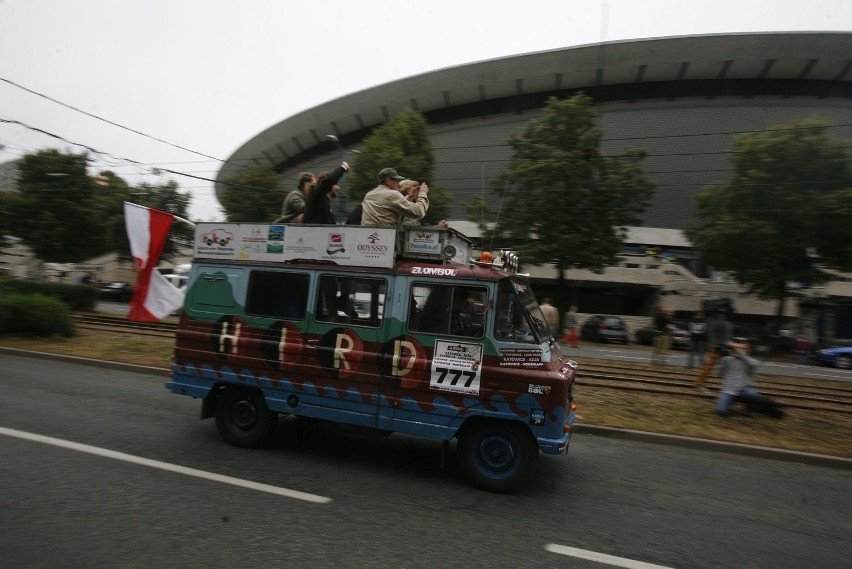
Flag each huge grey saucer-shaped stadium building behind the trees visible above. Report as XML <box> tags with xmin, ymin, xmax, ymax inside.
<box><xmin>216</xmin><ymin>32</ymin><xmax>852</xmax><ymax>328</ymax></box>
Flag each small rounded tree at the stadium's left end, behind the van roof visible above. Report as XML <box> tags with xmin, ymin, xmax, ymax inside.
<box><xmin>220</xmin><ymin>163</ymin><xmax>288</xmax><ymax>222</ymax></box>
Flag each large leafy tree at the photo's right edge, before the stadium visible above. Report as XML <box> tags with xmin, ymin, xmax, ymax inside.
<box><xmin>685</xmin><ymin>118</ymin><xmax>852</xmax><ymax>327</ymax></box>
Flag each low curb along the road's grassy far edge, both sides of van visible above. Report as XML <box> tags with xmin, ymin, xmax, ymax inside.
<box><xmin>6</xmin><ymin>346</ymin><xmax>852</xmax><ymax>470</ymax></box>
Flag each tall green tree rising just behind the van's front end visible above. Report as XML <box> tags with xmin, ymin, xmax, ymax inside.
<box><xmin>480</xmin><ymin>93</ymin><xmax>655</xmax><ymax>305</ymax></box>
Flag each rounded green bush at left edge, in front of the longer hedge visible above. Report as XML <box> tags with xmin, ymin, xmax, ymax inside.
<box><xmin>0</xmin><ymin>294</ymin><xmax>75</xmax><ymax>337</ymax></box>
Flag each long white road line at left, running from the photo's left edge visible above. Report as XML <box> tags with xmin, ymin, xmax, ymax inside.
<box><xmin>0</xmin><ymin>427</ymin><xmax>331</xmax><ymax>504</ymax></box>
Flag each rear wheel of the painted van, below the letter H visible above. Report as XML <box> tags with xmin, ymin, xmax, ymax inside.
<box><xmin>216</xmin><ymin>388</ymin><xmax>278</xmax><ymax>448</ymax></box>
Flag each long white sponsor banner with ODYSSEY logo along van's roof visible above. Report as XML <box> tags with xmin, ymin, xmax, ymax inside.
<box><xmin>193</xmin><ymin>222</ymin><xmax>396</xmax><ymax>268</ymax></box>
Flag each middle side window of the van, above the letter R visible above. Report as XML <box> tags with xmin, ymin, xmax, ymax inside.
<box><xmin>314</xmin><ymin>275</ymin><xmax>387</xmax><ymax>328</ymax></box>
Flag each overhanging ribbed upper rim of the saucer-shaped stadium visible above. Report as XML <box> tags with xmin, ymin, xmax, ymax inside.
<box><xmin>217</xmin><ymin>32</ymin><xmax>852</xmax><ymax>192</ymax></box>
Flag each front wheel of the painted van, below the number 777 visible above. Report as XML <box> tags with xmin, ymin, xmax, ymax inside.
<box><xmin>456</xmin><ymin>421</ymin><xmax>539</xmax><ymax>493</ymax></box>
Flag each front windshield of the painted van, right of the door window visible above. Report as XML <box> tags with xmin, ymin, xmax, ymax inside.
<box><xmin>495</xmin><ymin>279</ymin><xmax>551</xmax><ymax>344</ymax></box>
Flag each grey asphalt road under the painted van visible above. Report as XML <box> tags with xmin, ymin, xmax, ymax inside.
<box><xmin>5</xmin><ymin>354</ymin><xmax>852</xmax><ymax>569</ymax></box>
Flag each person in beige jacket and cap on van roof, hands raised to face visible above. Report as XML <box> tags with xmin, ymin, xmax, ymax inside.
<box><xmin>361</xmin><ymin>168</ymin><xmax>429</xmax><ymax>226</ymax></box>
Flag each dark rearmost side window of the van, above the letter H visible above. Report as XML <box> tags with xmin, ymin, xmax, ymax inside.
<box><xmin>246</xmin><ymin>271</ymin><xmax>309</xmax><ymax>320</ymax></box>
